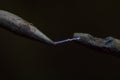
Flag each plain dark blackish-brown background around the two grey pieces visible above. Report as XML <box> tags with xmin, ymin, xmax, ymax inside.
<box><xmin>0</xmin><ymin>0</ymin><xmax>120</xmax><ymax>80</ymax></box>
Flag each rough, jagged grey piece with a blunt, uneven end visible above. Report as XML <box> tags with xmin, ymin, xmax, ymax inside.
<box><xmin>73</xmin><ymin>33</ymin><xmax>120</xmax><ymax>52</ymax></box>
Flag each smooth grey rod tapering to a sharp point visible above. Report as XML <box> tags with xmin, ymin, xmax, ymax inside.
<box><xmin>0</xmin><ymin>10</ymin><xmax>54</xmax><ymax>44</ymax></box>
